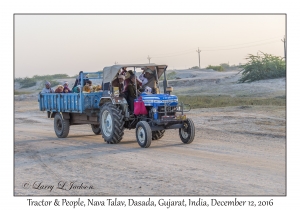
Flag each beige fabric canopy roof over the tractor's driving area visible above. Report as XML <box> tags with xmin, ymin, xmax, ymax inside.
<box><xmin>103</xmin><ymin>63</ymin><xmax>168</xmax><ymax>83</ymax></box>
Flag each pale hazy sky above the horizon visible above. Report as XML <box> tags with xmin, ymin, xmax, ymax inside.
<box><xmin>14</xmin><ymin>13</ymin><xmax>286</xmax><ymax>78</ymax></box>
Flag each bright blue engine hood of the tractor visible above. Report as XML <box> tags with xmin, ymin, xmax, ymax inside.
<box><xmin>141</xmin><ymin>93</ymin><xmax>178</xmax><ymax>106</ymax></box>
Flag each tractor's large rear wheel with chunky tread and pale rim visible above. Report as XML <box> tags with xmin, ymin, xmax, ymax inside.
<box><xmin>100</xmin><ymin>103</ymin><xmax>124</xmax><ymax>144</ymax></box>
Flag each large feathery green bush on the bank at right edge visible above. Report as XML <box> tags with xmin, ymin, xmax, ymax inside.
<box><xmin>239</xmin><ymin>53</ymin><xmax>286</xmax><ymax>83</ymax></box>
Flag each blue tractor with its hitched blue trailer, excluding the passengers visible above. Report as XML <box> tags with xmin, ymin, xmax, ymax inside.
<box><xmin>39</xmin><ymin>64</ymin><xmax>195</xmax><ymax>148</ymax></box>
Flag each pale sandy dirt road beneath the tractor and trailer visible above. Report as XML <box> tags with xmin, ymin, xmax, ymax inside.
<box><xmin>14</xmin><ymin>101</ymin><xmax>286</xmax><ymax>196</ymax></box>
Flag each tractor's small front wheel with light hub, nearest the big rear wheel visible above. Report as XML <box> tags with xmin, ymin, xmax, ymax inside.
<box><xmin>135</xmin><ymin>121</ymin><xmax>152</xmax><ymax>148</ymax></box>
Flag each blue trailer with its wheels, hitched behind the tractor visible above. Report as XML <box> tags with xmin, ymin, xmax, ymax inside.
<box><xmin>38</xmin><ymin>72</ymin><xmax>103</xmax><ymax>138</ymax></box>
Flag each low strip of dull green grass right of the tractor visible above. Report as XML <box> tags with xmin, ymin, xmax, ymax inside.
<box><xmin>178</xmin><ymin>95</ymin><xmax>286</xmax><ymax>109</ymax></box>
